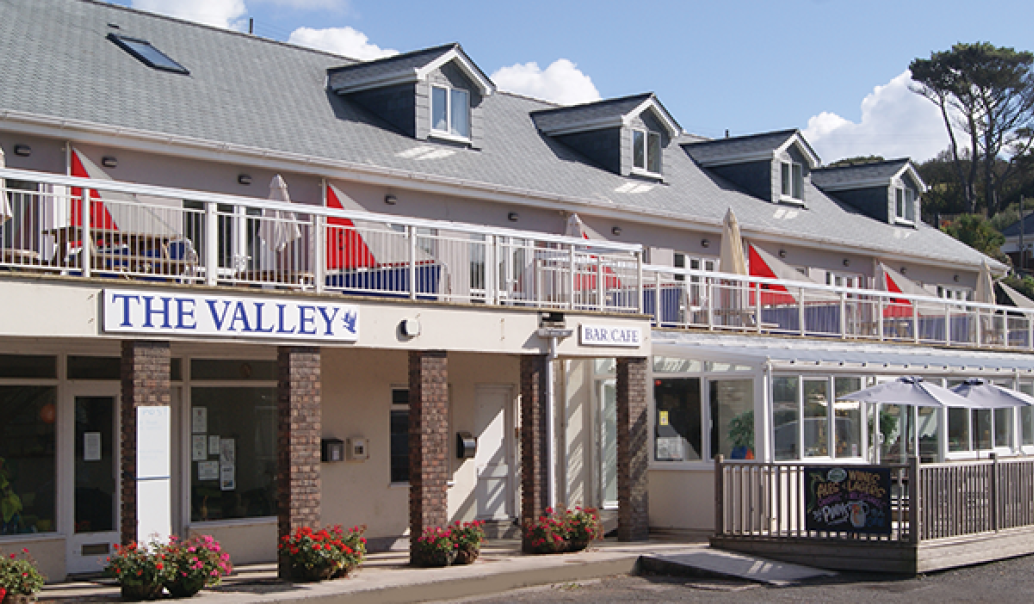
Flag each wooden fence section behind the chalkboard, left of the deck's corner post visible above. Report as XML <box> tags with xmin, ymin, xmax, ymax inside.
<box><xmin>714</xmin><ymin>459</ymin><xmax>917</xmax><ymax>543</ymax></box>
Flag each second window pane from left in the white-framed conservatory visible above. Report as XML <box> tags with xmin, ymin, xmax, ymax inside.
<box><xmin>710</xmin><ymin>380</ymin><xmax>754</xmax><ymax>459</ymax></box>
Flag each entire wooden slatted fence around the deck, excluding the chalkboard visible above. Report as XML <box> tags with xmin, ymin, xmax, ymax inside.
<box><xmin>714</xmin><ymin>456</ymin><xmax>1034</xmax><ymax>543</ymax></box>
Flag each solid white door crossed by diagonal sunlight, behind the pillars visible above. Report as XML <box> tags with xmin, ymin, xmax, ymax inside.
<box><xmin>474</xmin><ymin>386</ymin><xmax>514</xmax><ymax>520</ymax></box>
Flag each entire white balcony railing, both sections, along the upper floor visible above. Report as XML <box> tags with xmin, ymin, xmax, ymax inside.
<box><xmin>0</xmin><ymin>165</ymin><xmax>1034</xmax><ymax>350</ymax></box>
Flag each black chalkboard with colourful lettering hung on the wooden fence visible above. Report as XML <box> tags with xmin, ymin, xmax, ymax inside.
<box><xmin>804</xmin><ymin>466</ymin><xmax>890</xmax><ymax>535</ymax></box>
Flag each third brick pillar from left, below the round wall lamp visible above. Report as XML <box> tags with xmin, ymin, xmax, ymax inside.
<box><xmin>409</xmin><ymin>351</ymin><xmax>449</xmax><ymax>560</ymax></box>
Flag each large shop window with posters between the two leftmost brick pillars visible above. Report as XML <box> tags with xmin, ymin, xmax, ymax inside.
<box><xmin>190</xmin><ymin>387</ymin><xmax>277</xmax><ymax>522</ymax></box>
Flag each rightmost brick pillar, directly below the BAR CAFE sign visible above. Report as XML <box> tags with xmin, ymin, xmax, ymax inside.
<box><xmin>617</xmin><ymin>357</ymin><xmax>649</xmax><ymax>541</ymax></box>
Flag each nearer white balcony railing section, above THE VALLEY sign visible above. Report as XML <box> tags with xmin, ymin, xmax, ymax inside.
<box><xmin>0</xmin><ymin>170</ymin><xmax>642</xmax><ymax>312</ymax></box>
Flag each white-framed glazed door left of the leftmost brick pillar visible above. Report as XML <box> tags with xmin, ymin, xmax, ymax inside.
<box><xmin>64</xmin><ymin>384</ymin><xmax>120</xmax><ymax>574</ymax></box>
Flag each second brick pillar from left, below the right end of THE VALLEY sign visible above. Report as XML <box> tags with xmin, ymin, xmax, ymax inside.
<box><xmin>276</xmin><ymin>346</ymin><xmax>322</xmax><ymax>578</ymax></box>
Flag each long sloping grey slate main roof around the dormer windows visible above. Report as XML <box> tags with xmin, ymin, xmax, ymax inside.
<box><xmin>0</xmin><ymin>0</ymin><xmax>1000</xmax><ymax>267</ymax></box>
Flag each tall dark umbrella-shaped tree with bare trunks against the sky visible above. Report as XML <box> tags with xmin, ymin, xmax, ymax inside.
<box><xmin>909</xmin><ymin>42</ymin><xmax>1034</xmax><ymax>215</ymax></box>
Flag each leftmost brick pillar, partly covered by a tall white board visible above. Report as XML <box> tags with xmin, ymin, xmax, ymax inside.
<box><xmin>120</xmin><ymin>340</ymin><xmax>172</xmax><ymax>544</ymax></box>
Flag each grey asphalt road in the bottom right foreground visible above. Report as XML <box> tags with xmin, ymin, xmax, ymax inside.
<box><xmin>453</xmin><ymin>556</ymin><xmax>1034</xmax><ymax>604</ymax></box>
